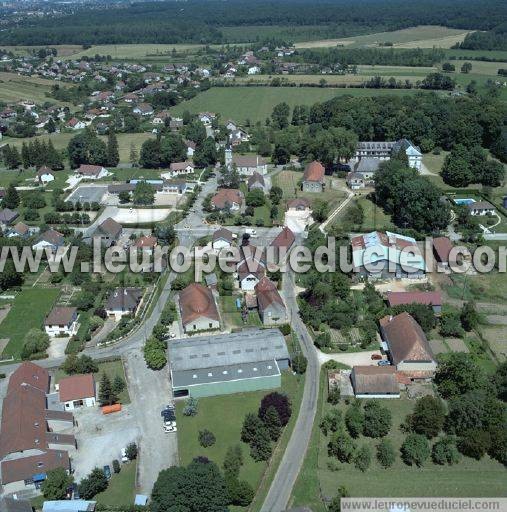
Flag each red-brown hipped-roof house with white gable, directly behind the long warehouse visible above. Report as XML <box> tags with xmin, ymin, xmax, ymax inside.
<box><xmin>178</xmin><ymin>283</ymin><xmax>220</xmax><ymax>332</ymax></box>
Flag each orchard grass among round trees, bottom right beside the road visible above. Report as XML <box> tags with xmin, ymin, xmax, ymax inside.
<box><xmin>291</xmin><ymin>375</ymin><xmax>506</xmax><ymax>512</ymax></box>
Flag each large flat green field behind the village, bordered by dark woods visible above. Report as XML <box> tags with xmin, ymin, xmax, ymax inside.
<box><xmin>171</xmin><ymin>87</ymin><xmax>422</xmax><ymax>123</ymax></box>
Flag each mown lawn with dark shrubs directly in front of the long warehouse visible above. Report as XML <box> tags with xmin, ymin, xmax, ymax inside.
<box><xmin>176</xmin><ymin>372</ymin><xmax>302</xmax><ymax>502</ymax></box>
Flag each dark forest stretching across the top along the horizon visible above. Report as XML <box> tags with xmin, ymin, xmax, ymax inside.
<box><xmin>0</xmin><ymin>0</ymin><xmax>507</xmax><ymax>45</ymax></box>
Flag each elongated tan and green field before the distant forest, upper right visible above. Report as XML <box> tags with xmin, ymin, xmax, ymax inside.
<box><xmin>296</xmin><ymin>25</ymin><xmax>474</xmax><ymax>48</ymax></box>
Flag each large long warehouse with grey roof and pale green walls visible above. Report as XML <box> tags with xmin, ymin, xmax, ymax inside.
<box><xmin>169</xmin><ymin>329</ymin><xmax>290</xmax><ymax>397</ymax></box>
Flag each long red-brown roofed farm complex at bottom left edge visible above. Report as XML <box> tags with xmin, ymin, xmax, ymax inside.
<box><xmin>0</xmin><ymin>362</ymin><xmax>76</xmax><ymax>495</ymax></box>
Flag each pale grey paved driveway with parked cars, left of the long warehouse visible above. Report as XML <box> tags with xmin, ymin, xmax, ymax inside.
<box><xmin>125</xmin><ymin>349</ymin><xmax>178</xmax><ymax>495</ymax></box>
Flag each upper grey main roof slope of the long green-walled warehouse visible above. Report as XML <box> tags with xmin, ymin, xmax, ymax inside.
<box><xmin>169</xmin><ymin>329</ymin><xmax>289</xmax><ymax>371</ymax></box>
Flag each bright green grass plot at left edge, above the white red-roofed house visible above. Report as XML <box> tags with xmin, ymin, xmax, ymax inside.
<box><xmin>0</xmin><ymin>288</ymin><xmax>60</xmax><ymax>359</ymax></box>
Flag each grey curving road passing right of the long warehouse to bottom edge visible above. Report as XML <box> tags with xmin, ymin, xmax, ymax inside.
<box><xmin>261</xmin><ymin>273</ymin><xmax>320</xmax><ymax>512</ymax></box>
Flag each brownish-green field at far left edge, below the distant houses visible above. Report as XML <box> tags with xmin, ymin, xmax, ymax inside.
<box><xmin>0</xmin><ymin>72</ymin><xmax>70</xmax><ymax>105</ymax></box>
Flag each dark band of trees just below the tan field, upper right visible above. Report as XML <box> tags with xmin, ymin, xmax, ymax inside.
<box><xmin>293</xmin><ymin>48</ymin><xmax>445</xmax><ymax>66</ymax></box>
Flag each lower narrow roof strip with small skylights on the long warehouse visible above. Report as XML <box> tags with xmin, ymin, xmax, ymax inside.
<box><xmin>172</xmin><ymin>359</ymin><xmax>280</xmax><ymax>387</ymax></box>
